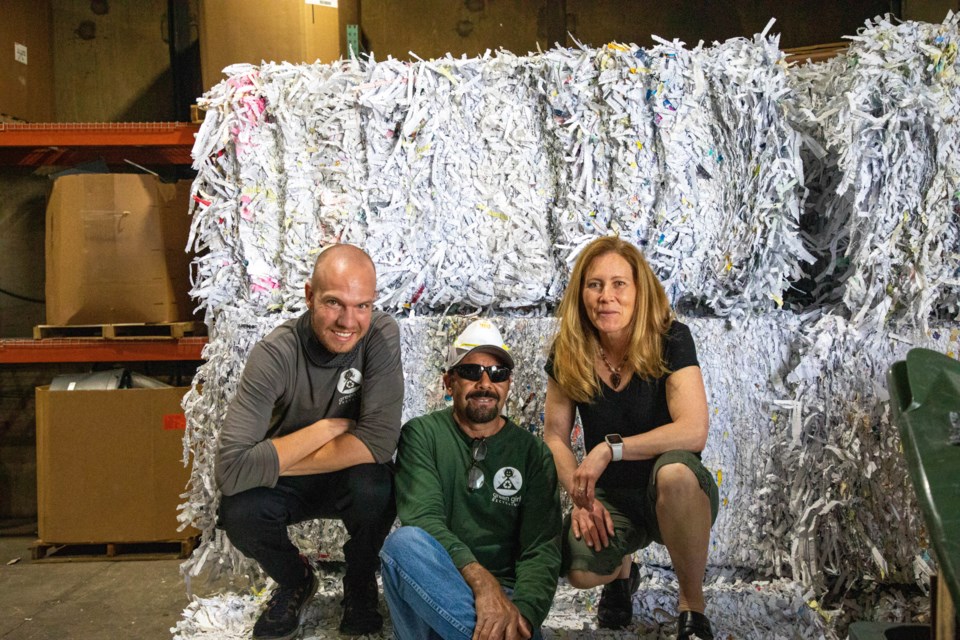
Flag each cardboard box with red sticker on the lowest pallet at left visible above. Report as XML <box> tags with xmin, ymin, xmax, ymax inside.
<box><xmin>36</xmin><ymin>387</ymin><xmax>196</xmax><ymax>544</ymax></box>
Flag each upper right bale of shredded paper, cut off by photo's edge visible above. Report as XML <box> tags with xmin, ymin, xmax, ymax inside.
<box><xmin>791</xmin><ymin>13</ymin><xmax>960</xmax><ymax>327</ymax></box>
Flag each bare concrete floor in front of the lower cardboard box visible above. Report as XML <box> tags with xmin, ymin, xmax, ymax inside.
<box><xmin>0</xmin><ymin>535</ymin><xmax>199</xmax><ymax>640</ymax></box>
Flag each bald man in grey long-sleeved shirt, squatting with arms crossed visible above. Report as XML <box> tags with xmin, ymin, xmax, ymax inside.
<box><xmin>216</xmin><ymin>245</ymin><xmax>403</xmax><ymax>640</ymax></box>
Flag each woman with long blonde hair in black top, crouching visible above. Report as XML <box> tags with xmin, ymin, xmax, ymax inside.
<box><xmin>544</xmin><ymin>237</ymin><xmax>718</xmax><ymax>640</ymax></box>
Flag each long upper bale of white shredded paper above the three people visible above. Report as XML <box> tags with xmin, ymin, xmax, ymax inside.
<box><xmin>194</xmin><ymin>34</ymin><xmax>811</xmax><ymax>315</ymax></box>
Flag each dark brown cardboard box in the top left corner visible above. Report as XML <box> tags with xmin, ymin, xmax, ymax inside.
<box><xmin>0</xmin><ymin>0</ymin><xmax>54</xmax><ymax>122</ymax></box>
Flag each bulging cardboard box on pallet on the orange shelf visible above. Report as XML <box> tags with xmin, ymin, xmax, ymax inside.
<box><xmin>46</xmin><ymin>174</ymin><xmax>193</xmax><ymax>325</ymax></box>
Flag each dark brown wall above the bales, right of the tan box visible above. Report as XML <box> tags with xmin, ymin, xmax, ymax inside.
<box><xmin>358</xmin><ymin>0</ymin><xmax>892</xmax><ymax>60</ymax></box>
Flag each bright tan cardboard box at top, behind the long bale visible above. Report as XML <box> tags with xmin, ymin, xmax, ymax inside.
<box><xmin>200</xmin><ymin>0</ymin><xmax>340</xmax><ymax>91</ymax></box>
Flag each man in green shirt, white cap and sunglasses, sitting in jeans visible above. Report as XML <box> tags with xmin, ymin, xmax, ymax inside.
<box><xmin>380</xmin><ymin>320</ymin><xmax>561</xmax><ymax>640</ymax></box>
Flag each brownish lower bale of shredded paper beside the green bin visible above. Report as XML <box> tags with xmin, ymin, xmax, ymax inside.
<box><xmin>760</xmin><ymin>316</ymin><xmax>948</xmax><ymax>595</ymax></box>
